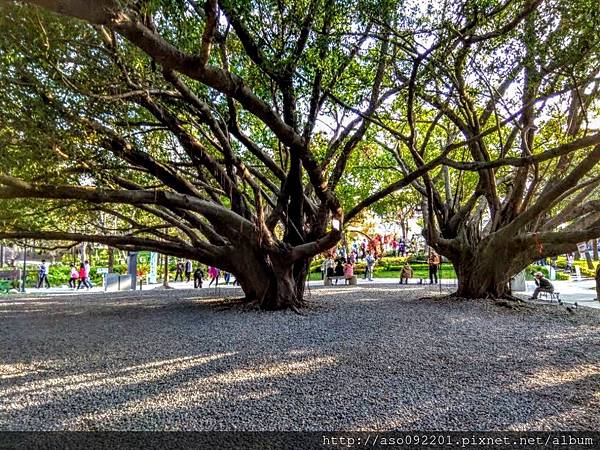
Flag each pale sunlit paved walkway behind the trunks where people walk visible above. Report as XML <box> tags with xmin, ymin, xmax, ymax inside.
<box><xmin>11</xmin><ymin>277</ymin><xmax>600</xmax><ymax>309</ymax></box>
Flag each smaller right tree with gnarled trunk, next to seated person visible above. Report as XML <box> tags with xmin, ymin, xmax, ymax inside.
<box><xmin>354</xmin><ymin>0</ymin><xmax>600</xmax><ymax>298</ymax></box>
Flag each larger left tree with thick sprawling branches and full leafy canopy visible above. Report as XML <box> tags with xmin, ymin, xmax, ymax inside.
<box><xmin>0</xmin><ymin>0</ymin><xmax>439</xmax><ymax>308</ymax></box>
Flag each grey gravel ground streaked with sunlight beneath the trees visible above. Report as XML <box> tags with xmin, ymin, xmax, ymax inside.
<box><xmin>0</xmin><ymin>285</ymin><xmax>600</xmax><ymax>430</ymax></box>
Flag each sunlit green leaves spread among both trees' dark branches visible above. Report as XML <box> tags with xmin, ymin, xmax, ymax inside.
<box><xmin>0</xmin><ymin>0</ymin><xmax>600</xmax><ymax>306</ymax></box>
